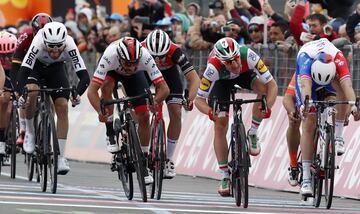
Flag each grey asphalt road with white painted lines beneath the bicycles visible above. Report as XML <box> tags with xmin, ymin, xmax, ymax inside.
<box><xmin>0</xmin><ymin>158</ymin><xmax>360</xmax><ymax>214</ymax></box>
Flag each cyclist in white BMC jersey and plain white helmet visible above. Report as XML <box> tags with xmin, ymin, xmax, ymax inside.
<box><xmin>17</xmin><ymin>22</ymin><xmax>90</xmax><ymax>174</ymax></box>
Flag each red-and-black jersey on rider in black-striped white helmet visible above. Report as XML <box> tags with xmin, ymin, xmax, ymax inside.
<box><xmin>141</xmin><ymin>41</ymin><xmax>194</xmax><ymax>75</ymax></box>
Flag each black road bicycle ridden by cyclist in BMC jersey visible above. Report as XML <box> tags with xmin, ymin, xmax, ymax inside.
<box><xmin>23</xmin><ymin>86</ymin><xmax>77</xmax><ymax>193</ymax></box>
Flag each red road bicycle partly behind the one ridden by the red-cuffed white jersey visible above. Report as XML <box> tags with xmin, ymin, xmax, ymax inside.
<box><xmin>148</xmin><ymin>89</ymin><xmax>189</xmax><ymax>200</ymax></box>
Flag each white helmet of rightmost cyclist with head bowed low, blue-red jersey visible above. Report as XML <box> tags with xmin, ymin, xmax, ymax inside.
<box><xmin>311</xmin><ymin>52</ymin><xmax>336</xmax><ymax>85</ymax></box>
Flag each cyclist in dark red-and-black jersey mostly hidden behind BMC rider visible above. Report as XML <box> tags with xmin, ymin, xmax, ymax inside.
<box><xmin>10</xmin><ymin>13</ymin><xmax>52</xmax><ymax>145</ymax></box>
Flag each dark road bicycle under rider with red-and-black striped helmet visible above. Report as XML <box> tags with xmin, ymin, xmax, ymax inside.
<box><xmin>100</xmin><ymin>90</ymin><xmax>151</xmax><ymax>202</ymax></box>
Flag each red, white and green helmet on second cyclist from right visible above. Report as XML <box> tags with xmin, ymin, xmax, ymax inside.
<box><xmin>214</xmin><ymin>37</ymin><xmax>240</xmax><ymax>61</ymax></box>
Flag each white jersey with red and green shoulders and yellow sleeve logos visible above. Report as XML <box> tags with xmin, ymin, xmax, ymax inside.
<box><xmin>197</xmin><ymin>46</ymin><xmax>273</xmax><ymax>98</ymax></box>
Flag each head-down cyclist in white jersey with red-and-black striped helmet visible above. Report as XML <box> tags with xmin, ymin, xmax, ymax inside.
<box><xmin>88</xmin><ymin>37</ymin><xmax>169</xmax><ymax>184</ymax></box>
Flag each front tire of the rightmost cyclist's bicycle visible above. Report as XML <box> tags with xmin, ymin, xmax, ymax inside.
<box><xmin>324</xmin><ymin>126</ymin><xmax>335</xmax><ymax>209</ymax></box>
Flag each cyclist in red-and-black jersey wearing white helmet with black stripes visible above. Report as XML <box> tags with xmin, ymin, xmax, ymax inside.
<box><xmin>142</xmin><ymin>30</ymin><xmax>200</xmax><ymax>178</ymax></box>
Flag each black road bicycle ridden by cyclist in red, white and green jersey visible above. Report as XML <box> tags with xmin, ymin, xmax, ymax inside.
<box><xmin>213</xmin><ymin>86</ymin><xmax>267</xmax><ymax>208</ymax></box>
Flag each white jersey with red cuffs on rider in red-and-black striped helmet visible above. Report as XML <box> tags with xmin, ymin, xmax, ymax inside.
<box><xmin>92</xmin><ymin>40</ymin><xmax>163</xmax><ymax>85</ymax></box>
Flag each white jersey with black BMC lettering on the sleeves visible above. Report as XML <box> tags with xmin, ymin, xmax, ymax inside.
<box><xmin>21</xmin><ymin>29</ymin><xmax>86</xmax><ymax>72</ymax></box>
